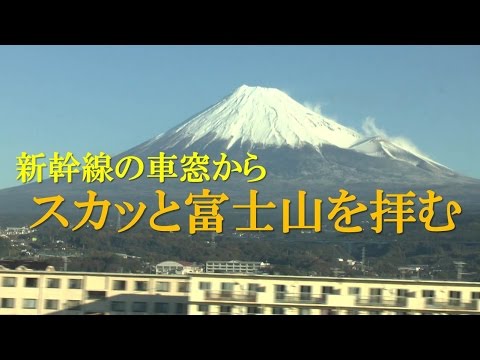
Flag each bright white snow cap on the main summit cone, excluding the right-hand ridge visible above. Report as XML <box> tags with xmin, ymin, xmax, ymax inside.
<box><xmin>161</xmin><ymin>85</ymin><xmax>361</xmax><ymax>149</ymax></box>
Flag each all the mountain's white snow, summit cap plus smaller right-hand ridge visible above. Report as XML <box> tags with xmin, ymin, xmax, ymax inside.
<box><xmin>136</xmin><ymin>85</ymin><xmax>452</xmax><ymax>173</ymax></box>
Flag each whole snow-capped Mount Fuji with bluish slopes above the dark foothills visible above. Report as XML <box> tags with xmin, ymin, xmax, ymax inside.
<box><xmin>0</xmin><ymin>85</ymin><xmax>480</xmax><ymax>218</ymax></box>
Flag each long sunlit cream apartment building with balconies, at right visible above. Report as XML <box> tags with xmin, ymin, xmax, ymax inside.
<box><xmin>188</xmin><ymin>274</ymin><xmax>480</xmax><ymax>315</ymax></box>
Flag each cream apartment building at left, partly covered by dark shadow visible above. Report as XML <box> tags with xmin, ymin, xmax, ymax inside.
<box><xmin>0</xmin><ymin>269</ymin><xmax>189</xmax><ymax>315</ymax></box>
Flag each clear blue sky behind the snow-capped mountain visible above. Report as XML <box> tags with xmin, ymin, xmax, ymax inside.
<box><xmin>0</xmin><ymin>46</ymin><xmax>480</xmax><ymax>188</ymax></box>
